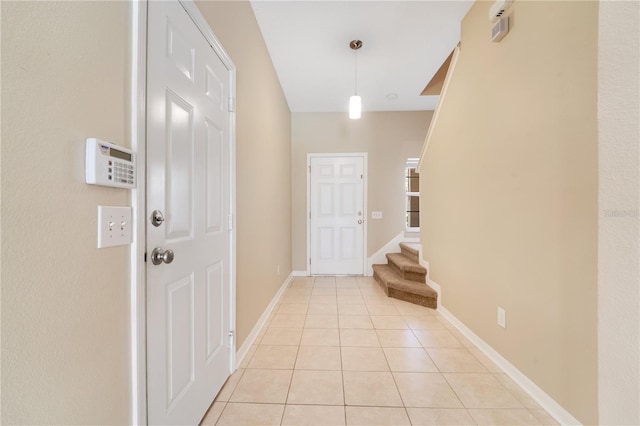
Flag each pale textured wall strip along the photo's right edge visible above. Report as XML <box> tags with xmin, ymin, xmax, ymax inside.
<box><xmin>598</xmin><ymin>1</ymin><xmax>640</xmax><ymax>425</ymax></box>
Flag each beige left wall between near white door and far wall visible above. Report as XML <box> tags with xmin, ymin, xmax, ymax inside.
<box><xmin>197</xmin><ymin>1</ymin><xmax>291</xmax><ymax>348</ymax></box>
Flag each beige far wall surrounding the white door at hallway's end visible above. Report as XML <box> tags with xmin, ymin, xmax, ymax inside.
<box><xmin>291</xmin><ymin>111</ymin><xmax>432</xmax><ymax>271</ymax></box>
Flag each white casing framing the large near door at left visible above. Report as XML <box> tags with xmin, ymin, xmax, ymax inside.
<box><xmin>129</xmin><ymin>0</ymin><xmax>236</xmax><ymax>424</ymax></box>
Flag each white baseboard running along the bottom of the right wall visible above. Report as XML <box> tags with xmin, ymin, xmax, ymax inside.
<box><xmin>436</xmin><ymin>286</ymin><xmax>581</xmax><ymax>425</ymax></box>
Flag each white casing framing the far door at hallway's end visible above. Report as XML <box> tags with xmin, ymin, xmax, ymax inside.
<box><xmin>306</xmin><ymin>152</ymin><xmax>369</xmax><ymax>276</ymax></box>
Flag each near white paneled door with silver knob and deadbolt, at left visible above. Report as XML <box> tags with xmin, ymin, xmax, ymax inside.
<box><xmin>146</xmin><ymin>1</ymin><xmax>232</xmax><ymax>424</ymax></box>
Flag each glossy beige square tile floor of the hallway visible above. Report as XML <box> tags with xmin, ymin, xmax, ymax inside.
<box><xmin>202</xmin><ymin>277</ymin><xmax>557</xmax><ymax>425</ymax></box>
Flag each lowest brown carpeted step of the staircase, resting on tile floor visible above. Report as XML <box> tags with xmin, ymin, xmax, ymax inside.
<box><xmin>373</xmin><ymin>265</ymin><xmax>438</xmax><ymax>308</ymax></box>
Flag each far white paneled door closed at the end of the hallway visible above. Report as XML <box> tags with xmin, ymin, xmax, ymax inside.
<box><xmin>309</xmin><ymin>155</ymin><xmax>366</xmax><ymax>275</ymax></box>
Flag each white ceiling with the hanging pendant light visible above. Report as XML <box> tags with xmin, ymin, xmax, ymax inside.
<box><xmin>251</xmin><ymin>0</ymin><xmax>473</xmax><ymax>112</ymax></box>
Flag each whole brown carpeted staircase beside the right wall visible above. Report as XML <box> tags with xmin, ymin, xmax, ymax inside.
<box><xmin>373</xmin><ymin>243</ymin><xmax>438</xmax><ymax>309</ymax></box>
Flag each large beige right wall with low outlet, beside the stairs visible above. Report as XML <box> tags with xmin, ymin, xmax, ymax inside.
<box><xmin>420</xmin><ymin>1</ymin><xmax>598</xmax><ymax>424</ymax></box>
